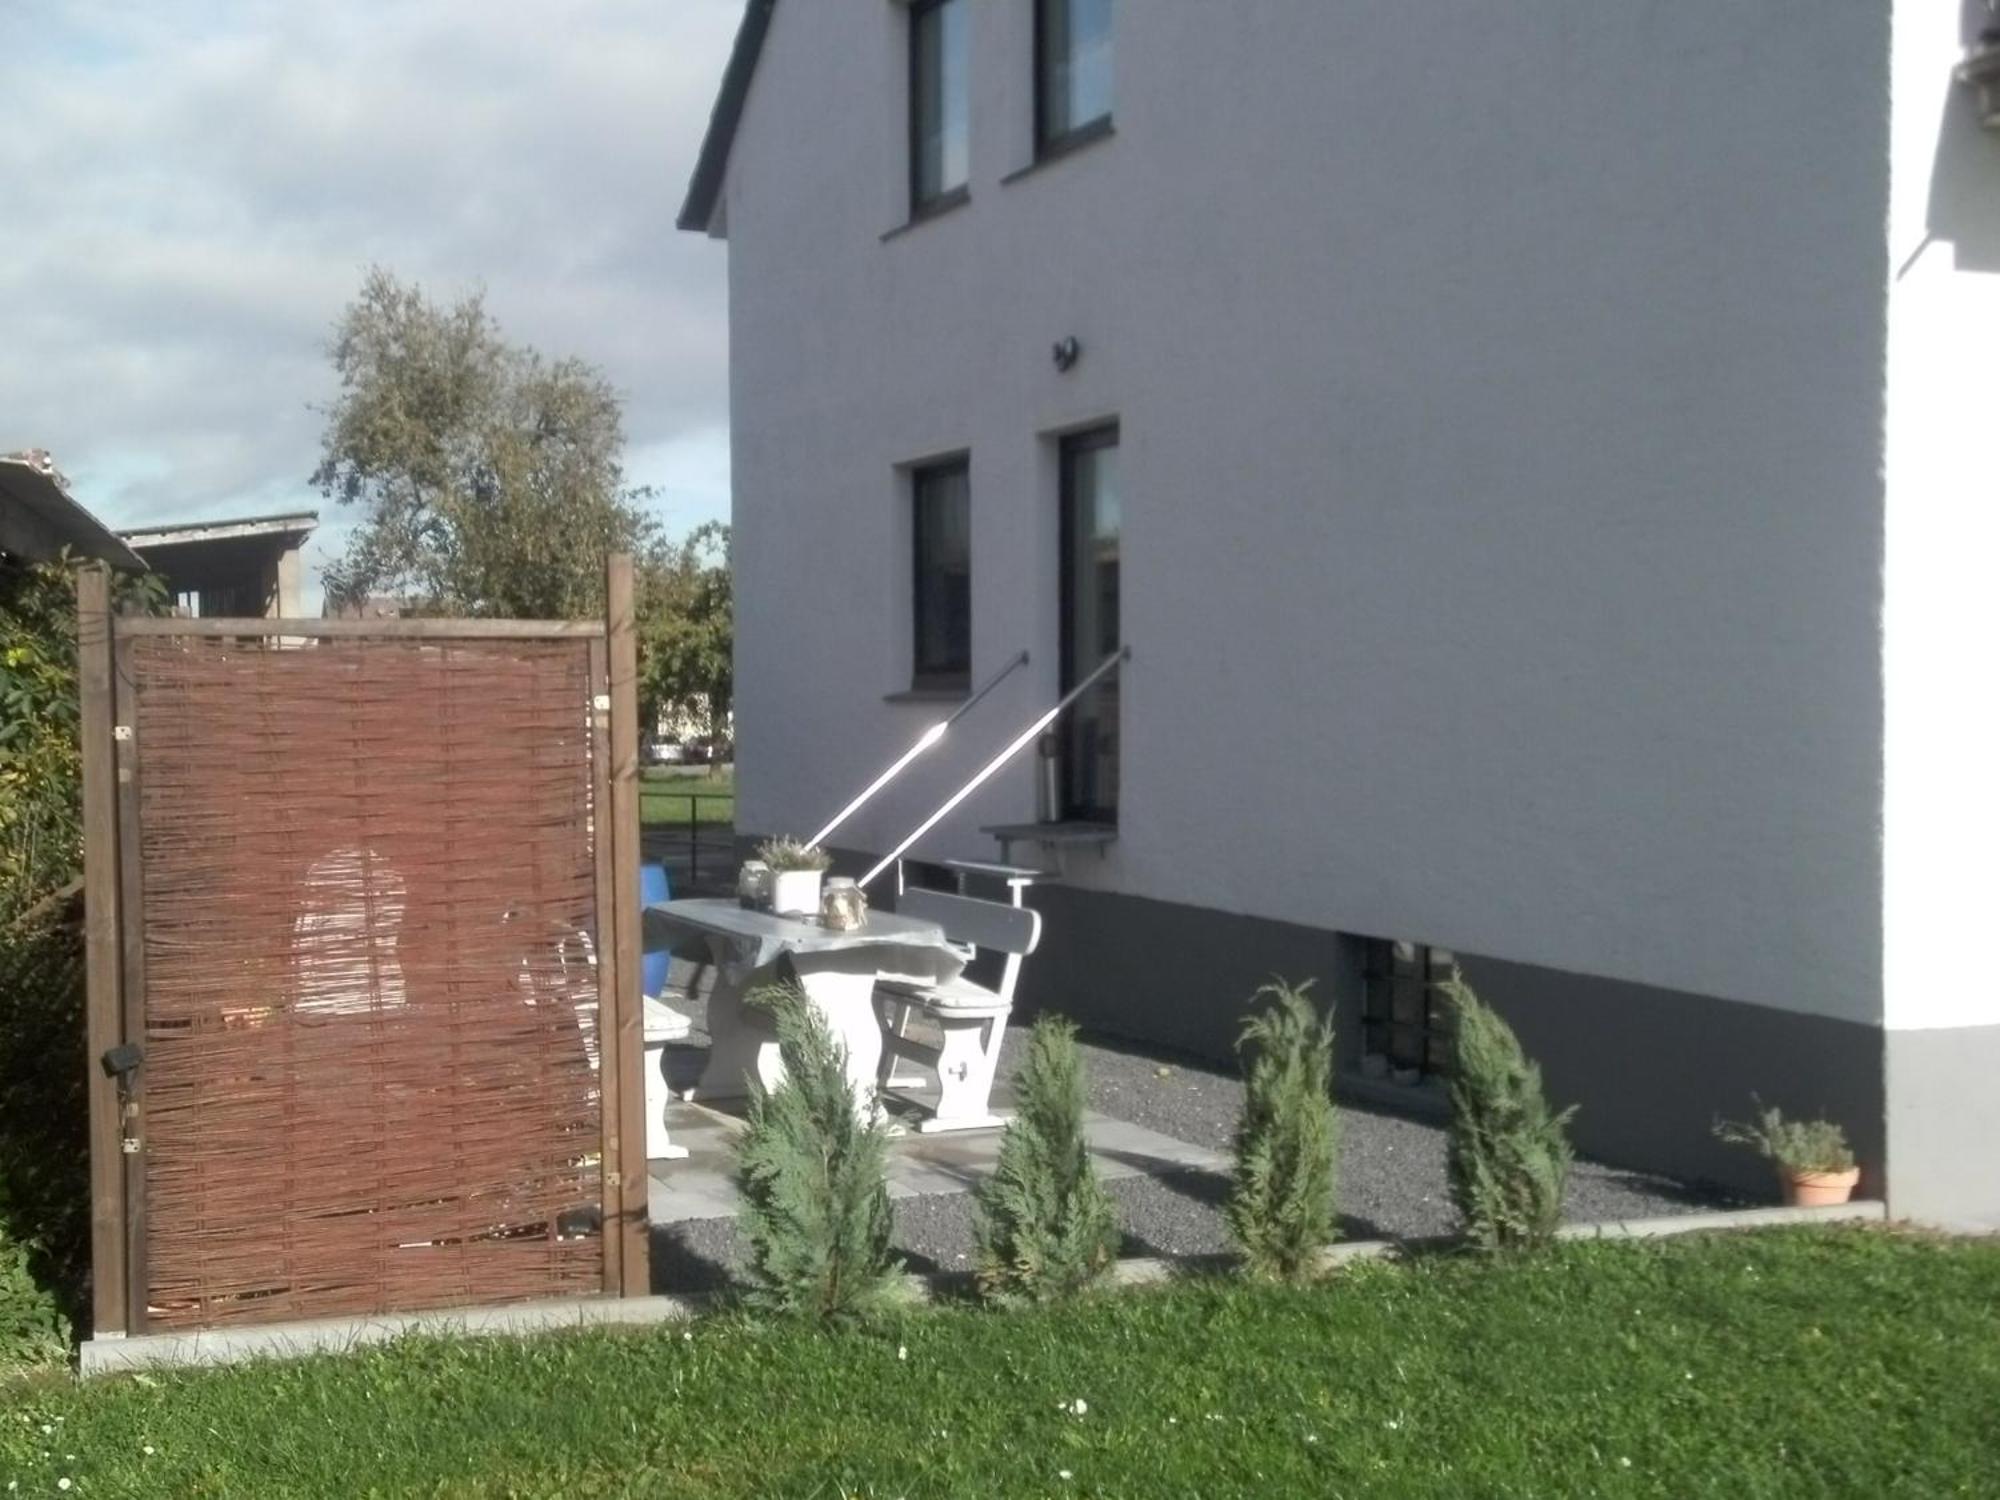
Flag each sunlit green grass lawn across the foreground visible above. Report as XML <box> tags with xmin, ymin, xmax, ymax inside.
<box><xmin>0</xmin><ymin>1230</ymin><xmax>2000</xmax><ymax>1500</ymax></box>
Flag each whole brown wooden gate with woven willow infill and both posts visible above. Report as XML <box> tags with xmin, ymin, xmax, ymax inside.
<box><xmin>78</xmin><ymin>558</ymin><xmax>648</xmax><ymax>1336</ymax></box>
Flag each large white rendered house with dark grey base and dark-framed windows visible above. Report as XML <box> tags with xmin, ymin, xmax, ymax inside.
<box><xmin>682</xmin><ymin>0</ymin><xmax>2000</xmax><ymax>1224</ymax></box>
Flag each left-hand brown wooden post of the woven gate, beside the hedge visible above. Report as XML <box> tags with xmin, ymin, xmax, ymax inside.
<box><xmin>76</xmin><ymin>564</ymin><xmax>132</xmax><ymax>1338</ymax></box>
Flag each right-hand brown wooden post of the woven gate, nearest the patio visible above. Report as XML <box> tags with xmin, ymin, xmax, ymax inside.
<box><xmin>600</xmin><ymin>552</ymin><xmax>652</xmax><ymax>1296</ymax></box>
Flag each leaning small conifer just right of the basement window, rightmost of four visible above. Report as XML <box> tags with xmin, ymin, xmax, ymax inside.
<box><xmin>1438</xmin><ymin>968</ymin><xmax>1576</xmax><ymax>1250</ymax></box>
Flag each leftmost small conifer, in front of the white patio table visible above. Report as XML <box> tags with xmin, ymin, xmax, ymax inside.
<box><xmin>736</xmin><ymin>986</ymin><xmax>902</xmax><ymax>1318</ymax></box>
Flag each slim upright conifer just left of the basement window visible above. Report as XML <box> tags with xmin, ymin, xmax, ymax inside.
<box><xmin>1226</xmin><ymin>980</ymin><xmax>1340</xmax><ymax>1280</ymax></box>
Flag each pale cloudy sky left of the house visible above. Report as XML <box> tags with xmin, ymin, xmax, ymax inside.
<box><xmin>0</xmin><ymin>0</ymin><xmax>742</xmax><ymax>610</ymax></box>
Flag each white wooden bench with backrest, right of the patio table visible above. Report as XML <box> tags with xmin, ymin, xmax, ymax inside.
<box><xmin>878</xmin><ymin>890</ymin><xmax>1042</xmax><ymax>1132</ymax></box>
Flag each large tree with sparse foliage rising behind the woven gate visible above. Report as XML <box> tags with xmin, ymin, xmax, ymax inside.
<box><xmin>312</xmin><ymin>268</ymin><xmax>662</xmax><ymax>620</ymax></box>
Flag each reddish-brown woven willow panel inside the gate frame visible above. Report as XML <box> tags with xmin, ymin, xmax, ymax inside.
<box><xmin>132</xmin><ymin>638</ymin><xmax>604</xmax><ymax>1328</ymax></box>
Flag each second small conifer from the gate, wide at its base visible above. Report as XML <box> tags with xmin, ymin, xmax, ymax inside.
<box><xmin>972</xmin><ymin>1016</ymin><xmax>1118</xmax><ymax>1302</ymax></box>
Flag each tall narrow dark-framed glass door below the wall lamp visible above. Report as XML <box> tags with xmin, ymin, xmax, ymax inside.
<box><xmin>1062</xmin><ymin>428</ymin><xmax>1124</xmax><ymax>822</ymax></box>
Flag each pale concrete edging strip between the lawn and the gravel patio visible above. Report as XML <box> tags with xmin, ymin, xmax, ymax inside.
<box><xmin>78</xmin><ymin>1198</ymin><xmax>1888</xmax><ymax>1380</ymax></box>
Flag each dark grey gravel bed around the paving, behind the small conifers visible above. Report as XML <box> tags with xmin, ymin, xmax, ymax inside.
<box><xmin>654</xmin><ymin>980</ymin><xmax>1728</xmax><ymax>1292</ymax></box>
